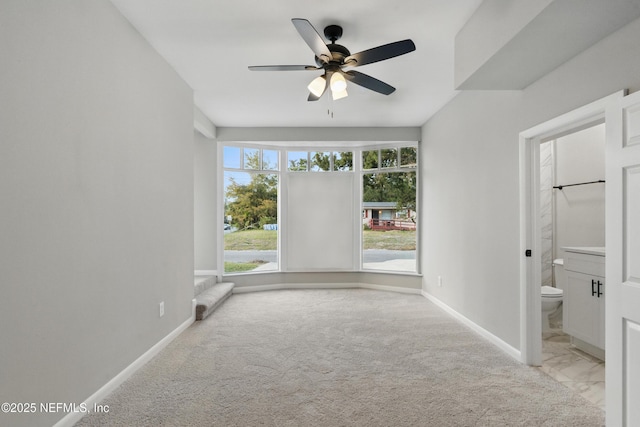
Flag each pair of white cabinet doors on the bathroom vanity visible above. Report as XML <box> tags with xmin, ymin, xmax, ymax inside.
<box><xmin>562</xmin><ymin>271</ymin><xmax>604</xmax><ymax>347</ymax></box>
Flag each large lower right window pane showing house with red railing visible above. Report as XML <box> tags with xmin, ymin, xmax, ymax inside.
<box><xmin>362</xmin><ymin>172</ymin><xmax>417</xmax><ymax>272</ymax></box>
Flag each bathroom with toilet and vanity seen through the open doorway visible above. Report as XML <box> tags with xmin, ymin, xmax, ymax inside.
<box><xmin>540</xmin><ymin>123</ymin><xmax>605</xmax><ymax>408</ymax></box>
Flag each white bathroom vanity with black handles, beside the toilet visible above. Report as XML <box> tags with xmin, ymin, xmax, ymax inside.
<box><xmin>562</xmin><ymin>247</ymin><xmax>605</xmax><ymax>360</ymax></box>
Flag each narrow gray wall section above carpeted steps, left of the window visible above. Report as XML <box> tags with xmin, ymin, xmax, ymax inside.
<box><xmin>193</xmin><ymin>132</ymin><xmax>222</xmax><ymax>271</ymax></box>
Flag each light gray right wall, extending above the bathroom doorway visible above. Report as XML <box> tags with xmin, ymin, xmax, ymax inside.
<box><xmin>421</xmin><ymin>15</ymin><xmax>640</xmax><ymax>348</ymax></box>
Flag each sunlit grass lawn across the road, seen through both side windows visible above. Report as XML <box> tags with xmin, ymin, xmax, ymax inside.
<box><xmin>224</xmin><ymin>230</ymin><xmax>416</xmax><ymax>252</ymax></box>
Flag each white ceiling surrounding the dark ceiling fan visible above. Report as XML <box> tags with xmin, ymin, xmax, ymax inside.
<box><xmin>111</xmin><ymin>0</ymin><xmax>481</xmax><ymax>127</ymax></box>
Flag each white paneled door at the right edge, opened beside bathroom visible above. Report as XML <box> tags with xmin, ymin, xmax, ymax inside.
<box><xmin>606</xmin><ymin>88</ymin><xmax>640</xmax><ymax>426</ymax></box>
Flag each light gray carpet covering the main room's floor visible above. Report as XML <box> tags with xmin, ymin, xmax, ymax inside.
<box><xmin>78</xmin><ymin>289</ymin><xmax>604</xmax><ymax>427</ymax></box>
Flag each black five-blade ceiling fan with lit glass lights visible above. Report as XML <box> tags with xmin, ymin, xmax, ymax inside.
<box><xmin>249</xmin><ymin>18</ymin><xmax>416</xmax><ymax>101</ymax></box>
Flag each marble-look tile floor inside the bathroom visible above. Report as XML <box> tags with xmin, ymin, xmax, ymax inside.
<box><xmin>540</xmin><ymin>329</ymin><xmax>605</xmax><ymax>410</ymax></box>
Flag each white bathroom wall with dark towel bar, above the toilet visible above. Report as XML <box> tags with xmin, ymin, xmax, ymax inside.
<box><xmin>553</xmin><ymin>124</ymin><xmax>605</xmax><ymax>258</ymax></box>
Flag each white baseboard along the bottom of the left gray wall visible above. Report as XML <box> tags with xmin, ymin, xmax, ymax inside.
<box><xmin>53</xmin><ymin>314</ymin><xmax>196</xmax><ymax>427</ymax></box>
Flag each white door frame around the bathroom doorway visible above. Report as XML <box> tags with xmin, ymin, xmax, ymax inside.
<box><xmin>519</xmin><ymin>91</ymin><xmax>626</xmax><ymax>366</ymax></box>
